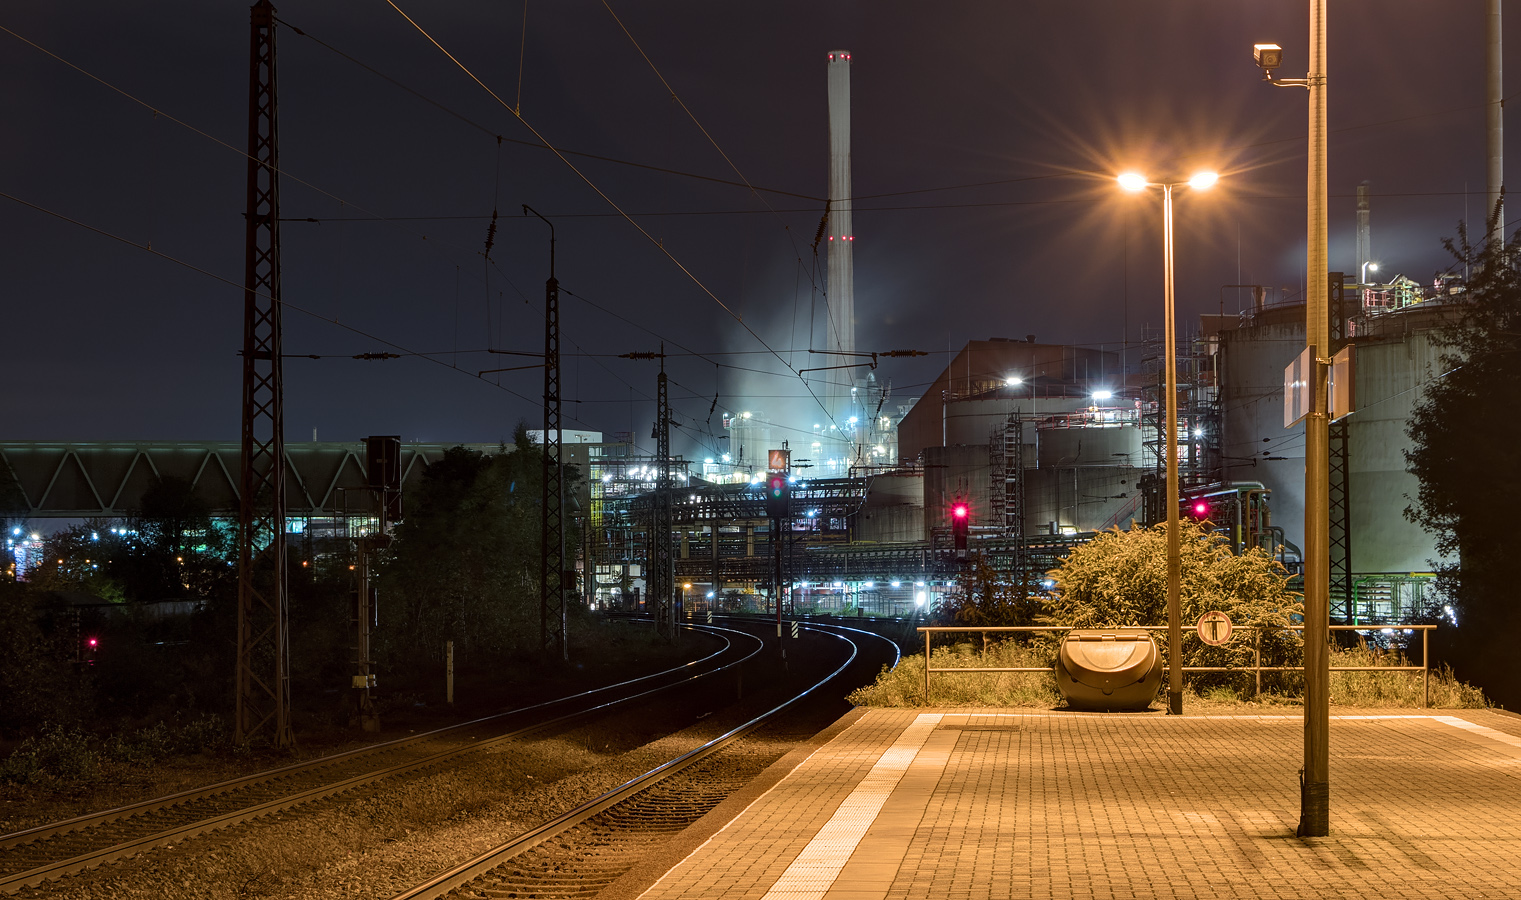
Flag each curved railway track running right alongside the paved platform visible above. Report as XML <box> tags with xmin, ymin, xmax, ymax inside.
<box><xmin>392</xmin><ymin>623</ymin><xmax>897</xmax><ymax>900</ymax></box>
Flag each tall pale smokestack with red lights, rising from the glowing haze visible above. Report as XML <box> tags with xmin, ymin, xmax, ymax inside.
<box><xmin>824</xmin><ymin>50</ymin><xmax>855</xmax><ymax>430</ymax></box>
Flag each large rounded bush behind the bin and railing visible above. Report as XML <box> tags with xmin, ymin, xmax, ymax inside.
<box><xmin>1045</xmin><ymin>521</ymin><xmax>1303</xmax><ymax>686</ymax></box>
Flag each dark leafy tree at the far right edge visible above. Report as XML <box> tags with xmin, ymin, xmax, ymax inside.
<box><xmin>1405</xmin><ymin>216</ymin><xmax>1521</xmax><ymax>704</ymax></box>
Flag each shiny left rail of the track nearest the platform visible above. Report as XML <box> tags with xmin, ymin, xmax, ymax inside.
<box><xmin>391</xmin><ymin>625</ymin><xmax>887</xmax><ymax>900</ymax></box>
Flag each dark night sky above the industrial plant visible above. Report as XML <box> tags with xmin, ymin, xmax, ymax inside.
<box><xmin>0</xmin><ymin>0</ymin><xmax>1521</xmax><ymax>458</ymax></box>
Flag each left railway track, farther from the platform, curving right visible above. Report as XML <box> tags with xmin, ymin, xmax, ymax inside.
<box><xmin>0</xmin><ymin>625</ymin><xmax>764</xmax><ymax>892</ymax></box>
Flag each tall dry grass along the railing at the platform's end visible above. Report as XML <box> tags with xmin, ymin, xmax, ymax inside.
<box><xmin>849</xmin><ymin>642</ymin><xmax>1491</xmax><ymax>708</ymax></box>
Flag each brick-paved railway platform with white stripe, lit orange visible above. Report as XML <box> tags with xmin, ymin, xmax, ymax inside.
<box><xmin>625</xmin><ymin>710</ymin><xmax>1521</xmax><ymax>900</ymax></box>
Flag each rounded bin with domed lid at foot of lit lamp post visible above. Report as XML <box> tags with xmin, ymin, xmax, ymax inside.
<box><xmin>1056</xmin><ymin>628</ymin><xmax>1162</xmax><ymax>710</ymax></box>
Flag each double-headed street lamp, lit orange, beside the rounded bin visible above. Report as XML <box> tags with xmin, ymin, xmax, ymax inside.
<box><xmin>1119</xmin><ymin>172</ymin><xmax>1220</xmax><ymax>716</ymax></box>
